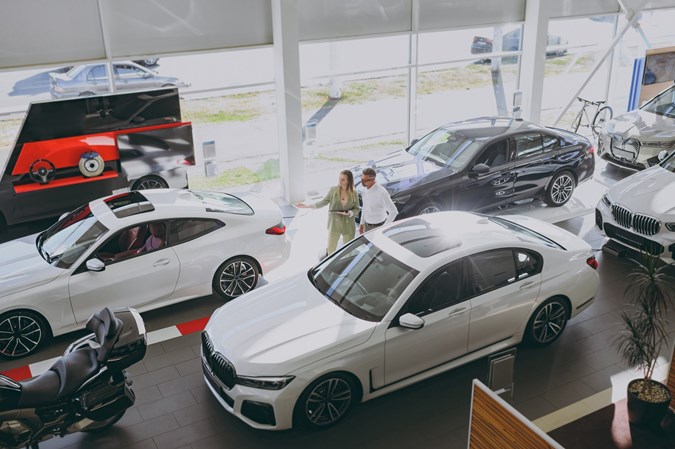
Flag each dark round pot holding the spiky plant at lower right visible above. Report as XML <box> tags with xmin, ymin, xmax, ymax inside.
<box><xmin>626</xmin><ymin>379</ymin><xmax>671</xmax><ymax>427</ymax></box>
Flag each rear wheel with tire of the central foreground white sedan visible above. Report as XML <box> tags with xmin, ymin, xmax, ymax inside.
<box><xmin>525</xmin><ymin>298</ymin><xmax>569</xmax><ymax>346</ymax></box>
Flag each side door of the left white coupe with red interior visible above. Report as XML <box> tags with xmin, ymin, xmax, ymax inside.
<box><xmin>68</xmin><ymin>221</ymin><xmax>180</xmax><ymax>322</ymax></box>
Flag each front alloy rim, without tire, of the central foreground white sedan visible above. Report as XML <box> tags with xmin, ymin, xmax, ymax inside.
<box><xmin>305</xmin><ymin>377</ymin><xmax>352</xmax><ymax>426</ymax></box>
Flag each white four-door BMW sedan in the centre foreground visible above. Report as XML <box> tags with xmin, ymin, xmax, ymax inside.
<box><xmin>202</xmin><ymin>212</ymin><xmax>598</xmax><ymax>429</ymax></box>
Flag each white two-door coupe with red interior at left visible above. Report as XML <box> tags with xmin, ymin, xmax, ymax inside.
<box><xmin>0</xmin><ymin>189</ymin><xmax>290</xmax><ymax>358</ymax></box>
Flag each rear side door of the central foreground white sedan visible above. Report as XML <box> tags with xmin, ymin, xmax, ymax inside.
<box><xmin>466</xmin><ymin>249</ymin><xmax>542</xmax><ymax>352</ymax></box>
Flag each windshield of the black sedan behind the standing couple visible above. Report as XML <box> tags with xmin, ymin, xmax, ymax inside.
<box><xmin>408</xmin><ymin>128</ymin><xmax>480</xmax><ymax>170</ymax></box>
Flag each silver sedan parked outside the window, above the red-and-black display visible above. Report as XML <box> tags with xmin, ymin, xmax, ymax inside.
<box><xmin>49</xmin><ymin>61</ymin><xmax>190</xmax><ymax>98</ymax></box>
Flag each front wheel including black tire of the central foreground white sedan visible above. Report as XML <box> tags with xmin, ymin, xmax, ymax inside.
<box><xmin>293</xmin><ymin>373</ymin><xmax>360</xmax><ymax>428</ymax></box>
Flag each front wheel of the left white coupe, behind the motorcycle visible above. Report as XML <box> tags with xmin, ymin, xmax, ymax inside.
<box><xmin>0</xmin><ymin>310</ymin><xmax>51</xmax><ymax>359</ymax></box>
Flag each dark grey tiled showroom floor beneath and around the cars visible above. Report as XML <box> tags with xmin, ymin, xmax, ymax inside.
<box><xmin>0</xmin><ymin>158</ymin><xmax>670</xmax><ymax>449</ymax></box>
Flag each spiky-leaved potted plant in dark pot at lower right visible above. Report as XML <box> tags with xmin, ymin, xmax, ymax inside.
<box><xmin>614</xmin><ymin>254</ymin><xmax>675</xmax><ymax>427</ymax></box>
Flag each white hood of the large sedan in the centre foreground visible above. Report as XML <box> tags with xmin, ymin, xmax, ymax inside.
<box><xmin>206</xmin><ymin>273</ymin><xmax>377</xmax><ymax>376</ymax></box>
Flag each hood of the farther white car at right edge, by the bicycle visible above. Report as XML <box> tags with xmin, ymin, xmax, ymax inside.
<box><xmin>608</xmin><ymin>110</ymin><xmax>675</xmax><ymax>141</ymax></box>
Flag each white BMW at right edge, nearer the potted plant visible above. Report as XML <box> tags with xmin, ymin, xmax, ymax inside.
<box><xmin>595</xmin><ymin>152</ymin><xmax>675</xmax><ymax>263</ymax></box>
